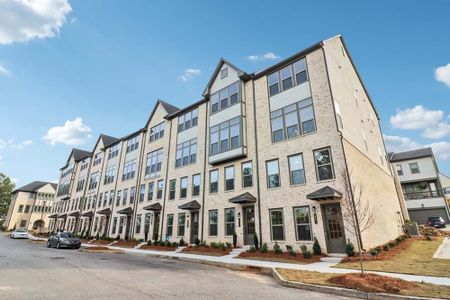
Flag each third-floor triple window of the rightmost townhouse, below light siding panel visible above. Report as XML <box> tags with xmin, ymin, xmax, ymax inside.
<box><xmin>270</xmin><ymin>98</ymin><xmax>316</xmax><ymax>143</ymax></box>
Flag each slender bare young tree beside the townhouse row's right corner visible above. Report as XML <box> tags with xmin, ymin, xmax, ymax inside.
<box><xmin>342</xmin><ymin>171</ymin><xmax>375</xmax><ymax>276</ymax></box>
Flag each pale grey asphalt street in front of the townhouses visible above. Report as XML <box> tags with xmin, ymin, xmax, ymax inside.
<box><xmin>0</xmin><ymin>233</ymin><xmax>349</xmax><ymax>300</ymax></box>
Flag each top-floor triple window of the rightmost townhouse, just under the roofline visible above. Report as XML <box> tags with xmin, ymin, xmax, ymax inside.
<box><xmin>267</xmin><ymin>58</ymin><xmax>308</xmax><ymax>96</ymax></box>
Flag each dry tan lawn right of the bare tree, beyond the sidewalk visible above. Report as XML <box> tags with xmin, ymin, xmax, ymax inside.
<box><xmin>334</xmin><ymin>238</ymin><xmax>450</xmax><ymax>277</ymax></box>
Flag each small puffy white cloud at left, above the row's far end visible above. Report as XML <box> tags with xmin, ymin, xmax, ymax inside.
<box><xmin>43</xmin><ymin>117</ymin><xmax>92</xmax><ymax>145</ymax></box>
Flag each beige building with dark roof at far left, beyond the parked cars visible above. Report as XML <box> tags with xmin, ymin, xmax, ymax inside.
<box><xmin>4</xmin><ymin>181</ymin><xmax>56</xmax><ymax>232</ymax></box>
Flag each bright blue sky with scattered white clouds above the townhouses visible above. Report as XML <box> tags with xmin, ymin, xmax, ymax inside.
<box><xmin>0</xmin><ymin>0</ymin><xmax>450</xmax><ymax>185</ymax></box>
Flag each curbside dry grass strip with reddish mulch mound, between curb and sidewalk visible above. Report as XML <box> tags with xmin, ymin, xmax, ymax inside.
<box><xmin>277</xmin><ymin>269</ymin><xmax>450</xmax><ymax>299</ymax></box>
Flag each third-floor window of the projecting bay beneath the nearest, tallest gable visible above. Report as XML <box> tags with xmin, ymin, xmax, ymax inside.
<box><xmin>209</xmin><ymin>117</ymin><xmax>241</xmax><ymax>155</ymax></box>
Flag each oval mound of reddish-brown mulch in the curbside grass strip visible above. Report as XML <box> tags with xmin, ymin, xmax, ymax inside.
<box><xmin>328</xmin><ymin>273</ymin><xmax>417</xmax><ymax>294</ymax></box>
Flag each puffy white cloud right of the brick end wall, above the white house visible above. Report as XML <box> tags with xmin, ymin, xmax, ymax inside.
<box><xmin>390</xmin><ymin>105</ymin><xmax>444</xmax><ymax>129</ymax></box>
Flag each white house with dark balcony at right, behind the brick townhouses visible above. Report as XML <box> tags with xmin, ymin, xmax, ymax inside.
<box><xmin>388</xmin><ymin>148</ymin><xmax>449</xmax><ymax>224</ymax></box>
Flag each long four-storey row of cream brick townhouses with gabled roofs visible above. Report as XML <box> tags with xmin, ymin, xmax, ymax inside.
<box><xmin>53</xmin><ymin>36</ymin><xmax>403</xmax><ymax>253</ymax></box>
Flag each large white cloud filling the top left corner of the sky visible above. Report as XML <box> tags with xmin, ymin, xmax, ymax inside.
<box><xmin>0</xmin><ymin>0</ymin><xmax>72</xmax><ymax>44</ymax></box>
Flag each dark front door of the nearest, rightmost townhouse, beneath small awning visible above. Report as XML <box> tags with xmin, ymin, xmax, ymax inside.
<box><xmin>323</xmin><ymin>203</ymin><xmax>345</xmax><ymax>253</ymax></box>
